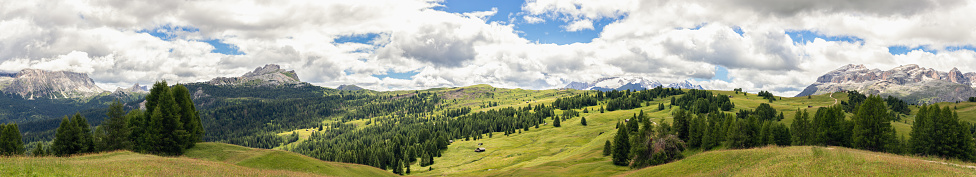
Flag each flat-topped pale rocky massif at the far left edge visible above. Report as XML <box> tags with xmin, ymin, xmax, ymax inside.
<box><xmin>0</xmin><ymin>69</ymin><xmax>105</xmax><ymax>99</ymax></box>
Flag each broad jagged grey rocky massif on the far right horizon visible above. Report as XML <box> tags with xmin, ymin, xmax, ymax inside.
<box><xmin>797</xmin><ymin>64</ymin><xmax>976</xmax><ymax>103</ymax></box>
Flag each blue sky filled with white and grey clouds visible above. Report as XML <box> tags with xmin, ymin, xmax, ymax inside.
<box><xmin>0</xmin><ymin>0</ymin><xmax>976</xmax><ymax>96</ymax></box>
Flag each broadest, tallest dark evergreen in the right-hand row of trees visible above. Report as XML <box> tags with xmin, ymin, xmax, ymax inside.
<box><xmin>852</xmin><ymin>95</ymin><xmax>895</xmax><ymax>151</ymax></box>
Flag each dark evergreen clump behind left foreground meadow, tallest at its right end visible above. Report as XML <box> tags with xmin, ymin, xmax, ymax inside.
<box><xmin>38</xmin><ymin>81</ymin><xmax>204</xmax><ymax>156</ymax></box>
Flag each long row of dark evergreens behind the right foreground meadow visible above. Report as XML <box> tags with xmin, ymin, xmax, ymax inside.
<box><xmin>604</xmin><ymin>90</ymin><xmax>976</xmax><ymax>168</ymax></box>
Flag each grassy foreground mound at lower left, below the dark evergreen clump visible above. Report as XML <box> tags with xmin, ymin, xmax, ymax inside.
<box><xmin>0</xmin><ymin>143</ymin><xmax>395</xmax><ymax>176</ymax></box>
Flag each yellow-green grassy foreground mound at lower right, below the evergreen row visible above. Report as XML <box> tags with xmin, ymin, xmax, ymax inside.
<box><xmin>619</xmin><ymin>146</ymin><xmax>976</xmax><ymax>176</ymax></box>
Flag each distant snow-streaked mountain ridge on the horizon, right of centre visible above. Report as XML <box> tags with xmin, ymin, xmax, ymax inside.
<box><xmin>563</xmin><ymin>77</ymin><xmax>704</xmax><ymax>91</ymax></box>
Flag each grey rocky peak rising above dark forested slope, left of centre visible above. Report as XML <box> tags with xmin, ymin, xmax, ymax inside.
<box><xmin>207</xmin><ymin>64</ymin><xmax>302</xmax><ymax>86</ymax></box>
